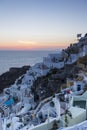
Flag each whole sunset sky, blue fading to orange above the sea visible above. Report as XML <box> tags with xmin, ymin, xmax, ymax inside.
<box><xmin>0</xmin><ymin>0</ymin><xmax>87</xmax><ymax>50</ymax></box>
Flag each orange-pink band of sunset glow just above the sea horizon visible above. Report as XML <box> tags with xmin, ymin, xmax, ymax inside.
<box><xmin>0</xmin><ymin>41</ymin><xmax>68</xmax><ymax>50</ymax></box>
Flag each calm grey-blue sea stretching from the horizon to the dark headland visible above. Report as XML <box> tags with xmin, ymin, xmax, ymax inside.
<box><xmin>0</xmin><ymin>50</ymin><xmax>58</xmax><ymax>75</ymax></box>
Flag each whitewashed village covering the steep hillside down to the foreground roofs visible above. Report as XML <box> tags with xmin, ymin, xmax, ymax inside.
<box><xmin>0</xmin><ymin>34</ymin><xmax>87</xmax><ymax>130</ymax></box>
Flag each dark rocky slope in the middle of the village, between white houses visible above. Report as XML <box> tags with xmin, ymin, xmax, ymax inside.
<box><xmin>32</xmin><ymin>63</ymin><xmax>79</xmax><ymax>101</ymax></box>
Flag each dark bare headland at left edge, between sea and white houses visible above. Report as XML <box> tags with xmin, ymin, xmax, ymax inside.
<box><xmin>0</xmin><ymin>66</ymin><xmax>30</xmax><ymax>92</ymax></box>
